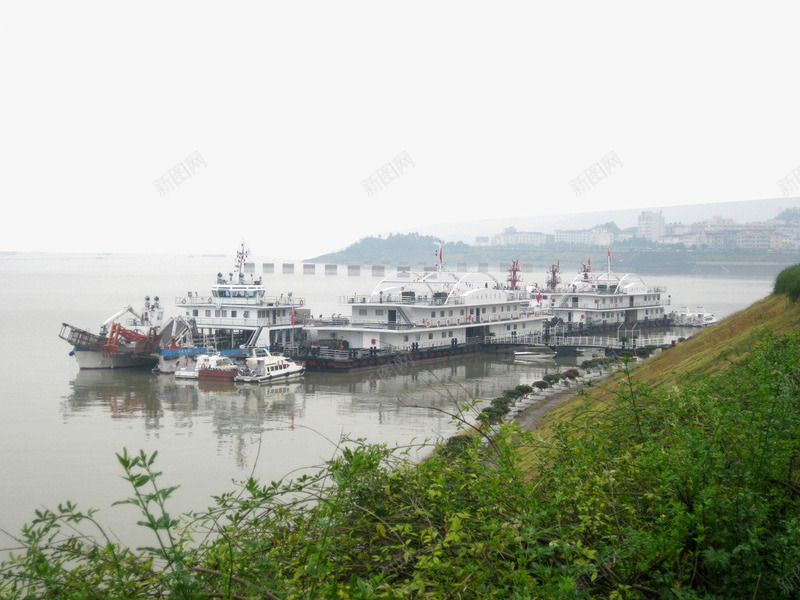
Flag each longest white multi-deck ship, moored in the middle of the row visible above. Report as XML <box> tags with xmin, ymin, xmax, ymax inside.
<box><xmin>304</xmin><ymin>254</ymin><xmax>550</xmax><ymax>370</ymax></box>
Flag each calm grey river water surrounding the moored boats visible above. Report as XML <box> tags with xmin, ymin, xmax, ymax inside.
<box><xmin>0</xmin><ymin>254</ymin><xmax>775</xmax><ymax>557</ymax></box>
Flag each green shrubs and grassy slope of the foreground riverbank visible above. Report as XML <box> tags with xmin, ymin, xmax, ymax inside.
<box><xmin>0</xmin><ymin>278</ymin><xmax>800</xmax><ymax>600</ymax></box>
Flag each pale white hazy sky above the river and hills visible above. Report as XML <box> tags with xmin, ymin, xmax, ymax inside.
<box><xmin>0</xmin><ymin>0</ymin><xmax>800</xmax><ymax>259</ymax></box>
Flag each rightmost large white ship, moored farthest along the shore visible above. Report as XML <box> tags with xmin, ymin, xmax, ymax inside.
<box><xmin>528</xmin><ymin>252</ymin><xmax>672</xmax><ymax>331</ymax></box>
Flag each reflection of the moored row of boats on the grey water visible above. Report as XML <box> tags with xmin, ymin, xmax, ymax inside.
<box><xmin>64</xmin><ymin>355</ymin><xmax>576</xmax><ymax>466</ymax></box>
